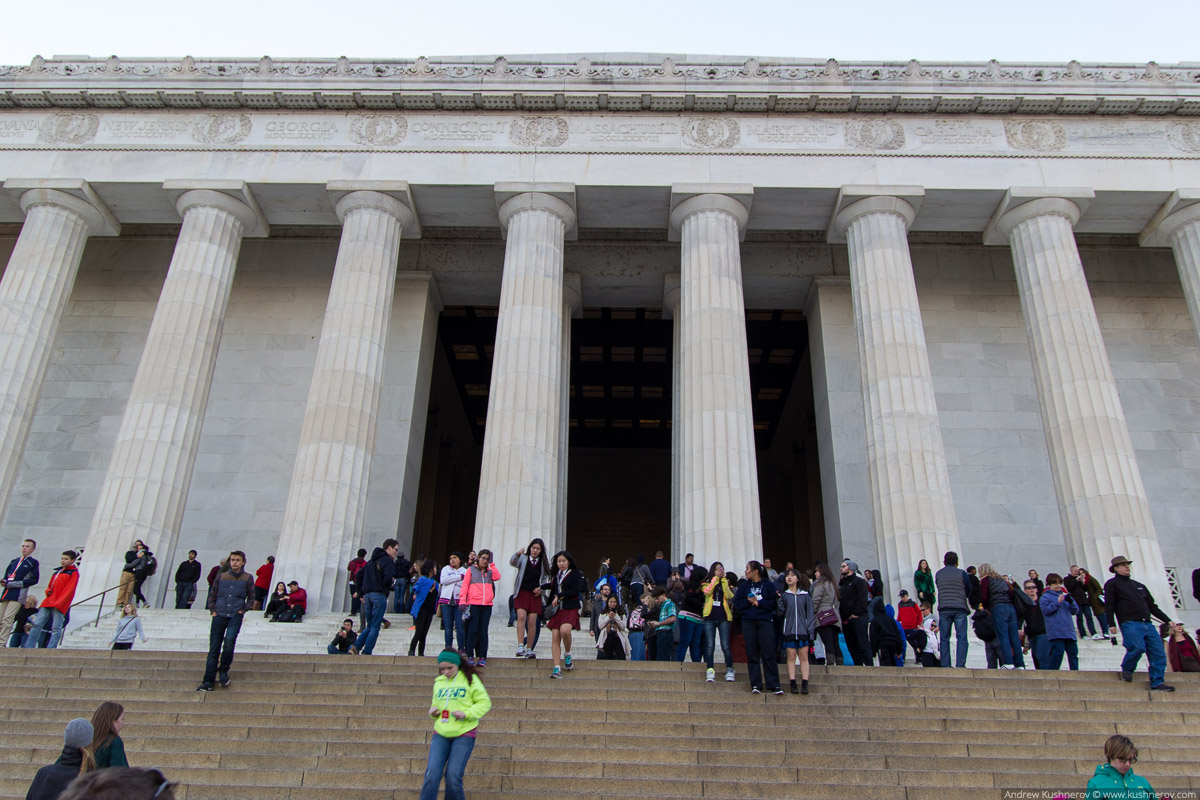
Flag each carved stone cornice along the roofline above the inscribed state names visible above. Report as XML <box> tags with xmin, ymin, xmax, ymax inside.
<box><xmin>0</xmin><ymin>55</ymin><xmax>1200</xmax><ymax>115</ymax></box>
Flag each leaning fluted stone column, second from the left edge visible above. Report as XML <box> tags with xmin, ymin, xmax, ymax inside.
<box><xmin>76</xmin><ymin>182</ymin><xmax>268</xmax><ymax>599</ymax></box>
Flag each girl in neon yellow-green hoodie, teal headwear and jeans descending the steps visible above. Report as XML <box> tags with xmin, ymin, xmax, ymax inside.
<box><xmin>420</xmin><ymin>650</ymin><xmax>492</xmax><ymax>800</ymax></box>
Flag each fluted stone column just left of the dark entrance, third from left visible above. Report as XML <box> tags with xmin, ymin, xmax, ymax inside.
<box><xmin>276</xmin><ymin>185</ymin><xmax>428</xmax><ymax>612</ymax></box>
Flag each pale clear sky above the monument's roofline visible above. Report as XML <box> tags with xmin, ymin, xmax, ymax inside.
<box><xmin>0</xmin><ymin>0</ymin><xmax>1200</xmax><ymax>65</ymax></box>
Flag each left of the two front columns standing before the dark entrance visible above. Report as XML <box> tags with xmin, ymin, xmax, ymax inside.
<box><xmin>474</xmin><ymin>184</ymin><xmax>575</xmax><ymax>570</ymax></box>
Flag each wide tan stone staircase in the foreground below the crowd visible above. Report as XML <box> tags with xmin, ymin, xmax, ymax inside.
<box><xmin>0</xmin><ymin>649</ymin><xmax>1200</xmax><ymax>800</ymax></box>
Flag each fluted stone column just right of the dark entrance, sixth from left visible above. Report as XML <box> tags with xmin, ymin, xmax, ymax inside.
<box><xmin>830</xmin><ymin>186</ymin><xmax>961</xmax><ymax>596</ymax></box>
